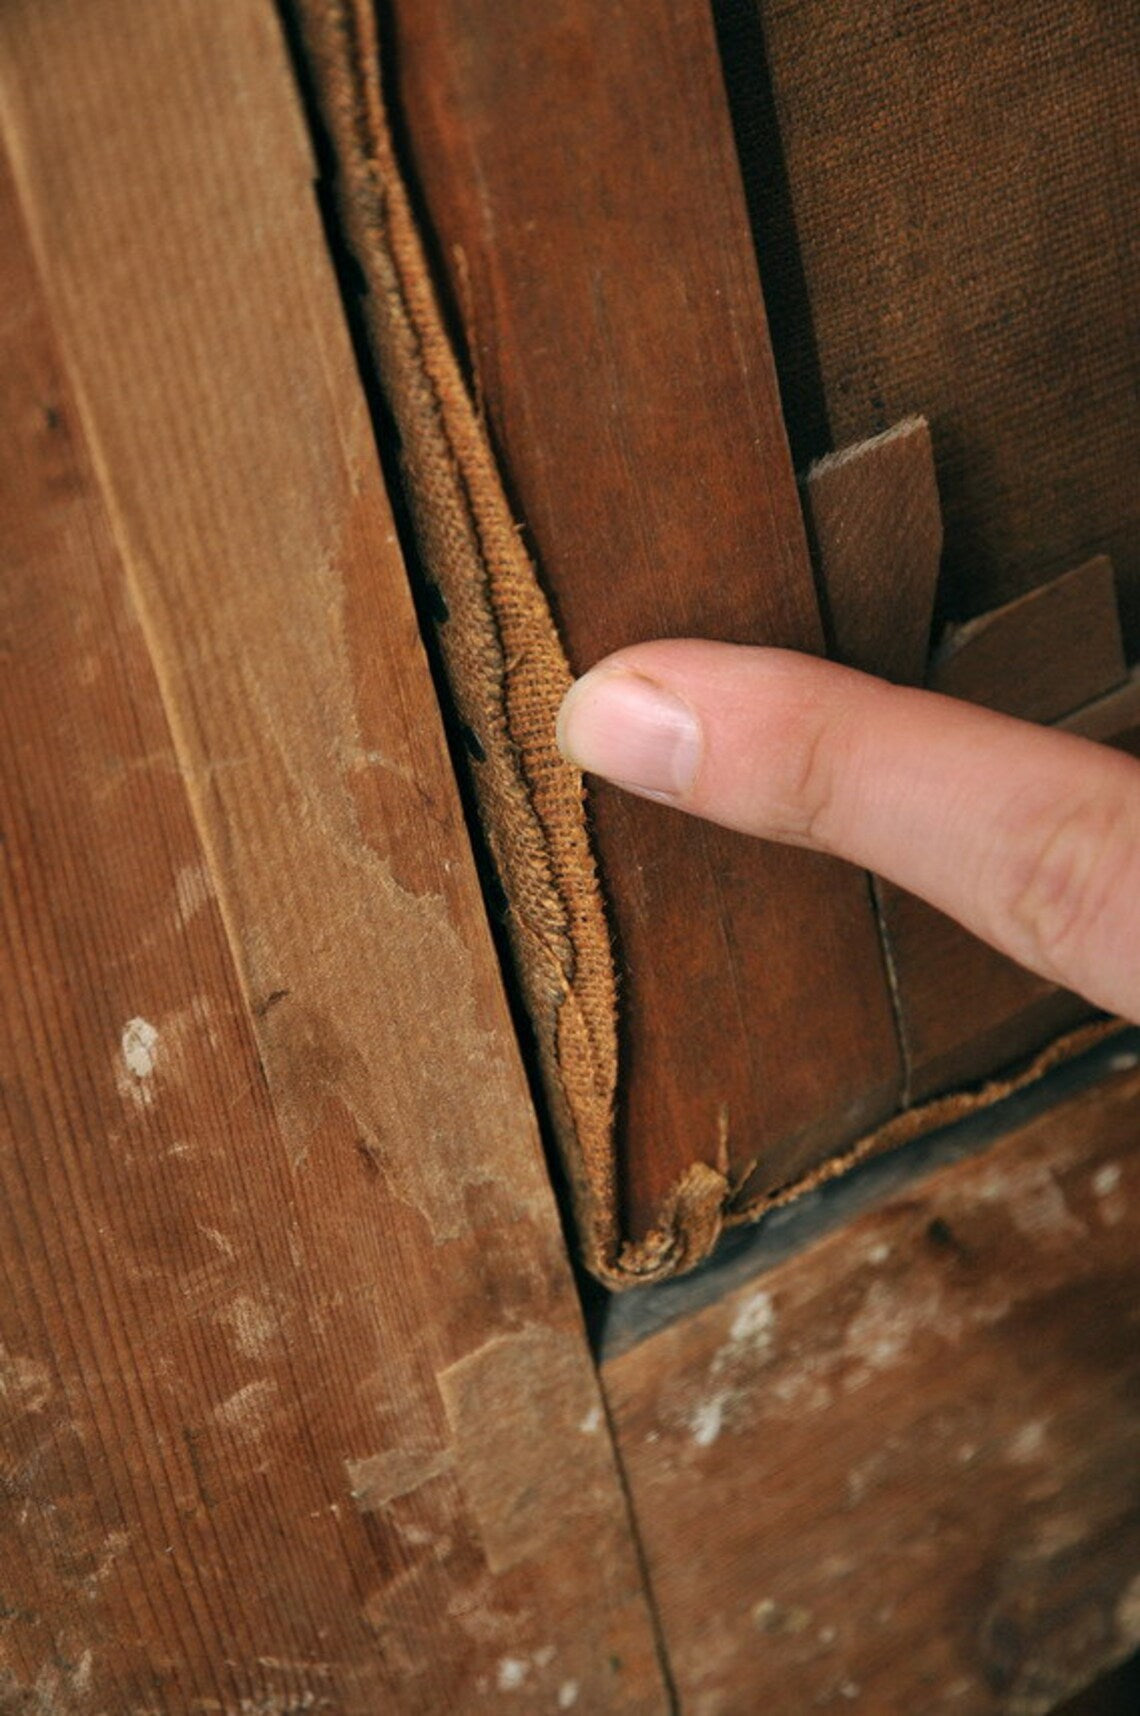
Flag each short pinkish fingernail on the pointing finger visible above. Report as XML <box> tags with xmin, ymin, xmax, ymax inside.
<box><xmin>558</xmin><ymin>668</ymin><xmax>700</xmax><ymax>800</ymax></box>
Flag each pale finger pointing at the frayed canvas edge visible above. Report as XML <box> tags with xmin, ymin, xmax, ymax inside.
<box><xmin>558</xmin><ymin>638</ymin><xmax>1140</xmax><ymax>1021</ymax></box>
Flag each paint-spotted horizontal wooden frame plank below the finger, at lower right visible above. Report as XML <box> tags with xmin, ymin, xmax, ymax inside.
<box><xmin>603</xmin><ymin>1052</ymin><xmax>1140</xmax><ymax>1716</ymax></box>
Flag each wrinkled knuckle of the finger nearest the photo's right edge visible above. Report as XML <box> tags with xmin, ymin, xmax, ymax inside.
<box><xmin>1006</xmin><ymin>800</ymin><xmax>1135</xmax><ymax>976</ymax></box>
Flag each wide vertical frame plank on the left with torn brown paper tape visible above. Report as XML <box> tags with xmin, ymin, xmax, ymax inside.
<box><xmin>0</xmin><ymin>0</ymin><xmax>666</xmax><ymax>1716</ymax></box>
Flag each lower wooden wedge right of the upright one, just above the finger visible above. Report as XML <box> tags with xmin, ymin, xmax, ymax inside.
<box><xmin>927</xmin><ymin>554</ymin><xmax>1128</xmax><ymax>721</ymax></box>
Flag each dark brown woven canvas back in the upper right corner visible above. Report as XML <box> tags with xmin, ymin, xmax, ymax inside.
<box><xmin>748</xmin><ymin>0</ymin><xmax>1140</xmax><ymax>652</ymax></box>
